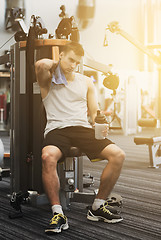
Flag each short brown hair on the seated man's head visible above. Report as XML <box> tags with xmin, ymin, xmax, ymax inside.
<box><xmin>62</xmin><ymin>42</ymin><xmax>84</xmax><ymax>57</ymax></box>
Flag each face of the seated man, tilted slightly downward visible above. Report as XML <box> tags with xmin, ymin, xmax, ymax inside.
<box><xmin>60</xmin><ymin>50</ymin><xmax>82</xmax><ymax>74</ymax></box>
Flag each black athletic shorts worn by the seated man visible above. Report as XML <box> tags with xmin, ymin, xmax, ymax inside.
<box><xmin>43</xmin><ymin>126</ymin><xmax>114</xmax><ymax>160</ymax></box>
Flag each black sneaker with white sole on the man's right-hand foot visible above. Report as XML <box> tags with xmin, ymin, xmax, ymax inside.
<box><xmin>87</xmin><ymin>204</ymin><xmax>123</xmax><ymax>223</ymax></box>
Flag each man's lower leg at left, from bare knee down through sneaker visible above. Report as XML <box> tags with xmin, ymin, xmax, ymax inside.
<box><xmin>42</xmin><ymin>146</ymin><xmax>69</xmax><ymax>234</ymax></box>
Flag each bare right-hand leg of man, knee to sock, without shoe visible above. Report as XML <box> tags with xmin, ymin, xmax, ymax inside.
<box><xmin>96</xmin><ymin>144</ymin><xmax>125</xmax><ymax>200</ymax></box>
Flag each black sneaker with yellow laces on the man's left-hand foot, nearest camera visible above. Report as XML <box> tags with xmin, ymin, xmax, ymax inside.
<box><xmin>45</xmin><ymin>213</ymin><xmax>69</xmax><ymax>234</ymax></box>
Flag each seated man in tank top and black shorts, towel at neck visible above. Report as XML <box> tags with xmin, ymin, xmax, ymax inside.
<box><xmin>35</xmin><ymin>42</ymin><xmax>125</xmax><ymax>233</ymax></box>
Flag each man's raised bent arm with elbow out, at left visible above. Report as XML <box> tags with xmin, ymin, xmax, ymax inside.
<box><xmin>35</xmin><ymin>58</ymin><xmax>58</xmax><ymax>98</ymax></box>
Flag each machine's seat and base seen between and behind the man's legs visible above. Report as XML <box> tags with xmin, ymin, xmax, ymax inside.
<box><xmin>58</xmin><ymin>147</ymin><xmax>123</xmax><ymax>210</ymax></box>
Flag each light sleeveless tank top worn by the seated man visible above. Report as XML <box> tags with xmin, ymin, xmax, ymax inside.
<box><xmin>43</xmin><ymin>73</ymin><xmax>91</xmax><ymax>136</ymax></box>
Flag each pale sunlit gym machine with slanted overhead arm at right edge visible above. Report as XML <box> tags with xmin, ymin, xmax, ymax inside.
<box><xmin>104</xmin><ymin>22</ymin><xmax>161</xmax><ymax>168</ymax></box>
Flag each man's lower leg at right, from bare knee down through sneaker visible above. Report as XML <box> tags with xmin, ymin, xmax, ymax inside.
<box><xmin>87</xmin><ymin>144</ymin><xmax>125</xmax><ymax>223</ymax></box>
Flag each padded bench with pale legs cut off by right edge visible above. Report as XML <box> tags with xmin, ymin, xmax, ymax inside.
<box><xmin>134</xmin><ymin>136</ymin><xmax>161</xmax><ymax>168</ymax></box>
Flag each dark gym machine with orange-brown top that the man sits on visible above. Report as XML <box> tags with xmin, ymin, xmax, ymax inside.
<box><xmin>0</xmin><ymin>16</ymin><xmax>122</xmax><ymax>218</ymax></box>
